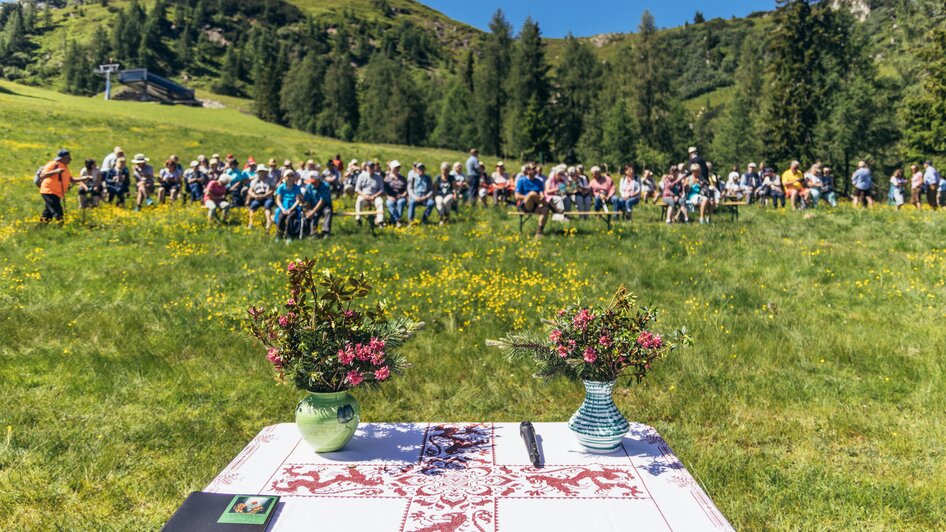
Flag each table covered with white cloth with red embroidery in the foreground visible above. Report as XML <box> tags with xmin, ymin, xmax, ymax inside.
<box><xmin>204</xmin><ymin>423</ymin><xmax>732</xmax><ymax>531</ymax></box>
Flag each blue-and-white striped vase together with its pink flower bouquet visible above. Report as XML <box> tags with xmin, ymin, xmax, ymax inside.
<box><xmin>487</xmin><ymin>288</ymin><xmax>689</xmax><ymax>453</ymax></box>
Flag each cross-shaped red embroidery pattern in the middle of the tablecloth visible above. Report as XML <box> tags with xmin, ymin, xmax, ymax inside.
<box><xmin>270</xmin><ymin>425</ymin><xmax>645</xmax><ymax>531</ymax></box>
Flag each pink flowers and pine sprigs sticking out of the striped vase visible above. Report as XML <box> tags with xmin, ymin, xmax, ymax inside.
<box><xmin>487</xmin><ymin>288</ymin><xmax>690</xmax><ymax>382</ymax></box>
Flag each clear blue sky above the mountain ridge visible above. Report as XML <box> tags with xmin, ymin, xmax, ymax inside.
<box><xmin>420</xmin><ymin>0</ymin><xmax>775</xmax><ymax>37</ymax></box>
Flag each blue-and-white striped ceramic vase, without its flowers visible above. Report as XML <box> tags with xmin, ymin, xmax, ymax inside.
<box><xmin>568</xmin><ymin>381</ymin><xmax>630</xmax><ymax>454</ymax></box>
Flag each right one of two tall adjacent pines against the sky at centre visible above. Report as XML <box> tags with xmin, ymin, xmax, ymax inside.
<box><xmin>506</xmin><ymin>18</ymin><xmax>550</xmax><ymax>160</ymax></box>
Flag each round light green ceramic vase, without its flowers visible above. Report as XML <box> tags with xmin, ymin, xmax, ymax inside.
<box><xmin>296</xmin><ymin>391</ymin><xmax>361</xmax><ymax>453</ymax></box>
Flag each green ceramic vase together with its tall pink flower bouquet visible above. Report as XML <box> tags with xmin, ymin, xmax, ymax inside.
<box><xmin>249</xmin><ymin>260</ymin><xmax>423</xmax><ymax>452</ymax></box>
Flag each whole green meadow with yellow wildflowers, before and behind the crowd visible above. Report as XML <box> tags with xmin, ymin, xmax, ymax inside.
<box><xmin>0</xmin><ymin>84</ymin><xmax>946</xmax><ymax>530</ymax></box>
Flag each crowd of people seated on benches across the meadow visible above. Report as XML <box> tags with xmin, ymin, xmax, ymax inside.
<box><xmin>36</xmin><ymin>147</ymin><xmax>946</xmax><ymax>236</ymax></box>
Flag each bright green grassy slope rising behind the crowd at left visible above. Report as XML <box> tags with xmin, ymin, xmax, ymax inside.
<box><xmin>0</xmin><ymin>82</ymin><xmax>465</xmax><ymax>204</ymax></box>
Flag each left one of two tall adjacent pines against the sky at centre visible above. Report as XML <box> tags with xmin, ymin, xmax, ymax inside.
<box><xmin>473</xmin><ymin>9</ymin><xmax>513</xmax><ymax>155</ymax></box>
